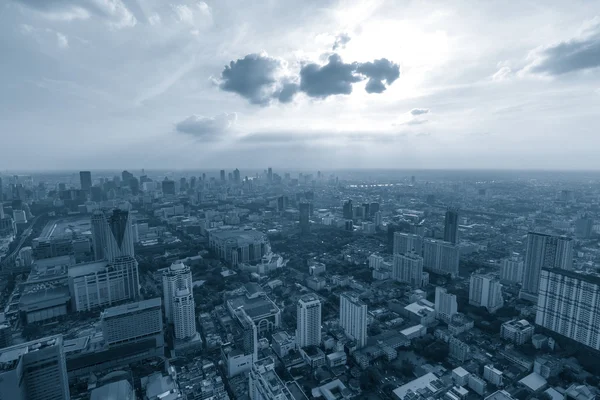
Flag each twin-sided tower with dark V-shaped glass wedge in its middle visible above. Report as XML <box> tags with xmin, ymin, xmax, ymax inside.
<box><xmin>92</xmin><ymin>209</ymin><xmax>135</xmax><ymax>261</ymax></box>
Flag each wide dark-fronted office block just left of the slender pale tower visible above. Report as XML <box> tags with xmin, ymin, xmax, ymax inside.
<box><xmin>100</xmin><ymin>297</ymin><xmax>164</xmax><ymax>347</ymax></box>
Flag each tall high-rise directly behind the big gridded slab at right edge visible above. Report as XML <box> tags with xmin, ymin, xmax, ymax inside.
<box><xmin>519</xmin><ymin>232</ymin><xmax>573</xmax><ymax>301</ymax></box>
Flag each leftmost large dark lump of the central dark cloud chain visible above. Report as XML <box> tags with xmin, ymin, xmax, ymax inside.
<box><xmin>219</xmin><ymin>54</ymin><xmax>282</xmax><ymax>105</ymax></box>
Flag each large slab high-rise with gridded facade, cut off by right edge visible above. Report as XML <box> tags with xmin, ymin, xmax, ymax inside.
<box><xmin>535</xmin><ymin>268</ymin><xmax>600</xmax><ymax>350</ymax></box>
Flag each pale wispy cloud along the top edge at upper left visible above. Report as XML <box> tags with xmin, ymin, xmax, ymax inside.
<box><xmin>13</xmin><ymin>0</ymin><xmax>137</xmax><ymax>28</ymax></box>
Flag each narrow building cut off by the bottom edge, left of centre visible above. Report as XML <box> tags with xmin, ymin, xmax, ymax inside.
<box><xmin>249</xmin><ymin>357</ymin><xmax>295</xmax><ymax>400</ymax></box>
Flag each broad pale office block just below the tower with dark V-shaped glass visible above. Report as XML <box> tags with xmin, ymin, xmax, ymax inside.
<box><xmin>68</xmin><ymin>256</ymin><xmax>140</xmax><ymax>311</ymax></box>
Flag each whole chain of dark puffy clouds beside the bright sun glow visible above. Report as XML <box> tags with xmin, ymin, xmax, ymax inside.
<box><xmin>219</xmin><ymin>54</ymin><xmax>400</xmax><ymax>105</ymax></box>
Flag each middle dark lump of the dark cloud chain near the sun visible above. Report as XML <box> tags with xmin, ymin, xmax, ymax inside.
<box><xmin>300</xmin><ymin>54</ymin><xmax>364</xmax><ymax>98</ymax></box>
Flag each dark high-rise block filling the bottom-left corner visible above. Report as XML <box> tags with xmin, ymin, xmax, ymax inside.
<box><xmin>0</xmin><ymin>335</ymin><xmax>70</xmax><ymax>400</ymax></box>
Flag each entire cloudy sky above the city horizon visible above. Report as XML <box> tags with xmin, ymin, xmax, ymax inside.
<box><xmin>0</xmin><ymin>0</ymin><xmax>600</xmax><ymax>170</ymax></box>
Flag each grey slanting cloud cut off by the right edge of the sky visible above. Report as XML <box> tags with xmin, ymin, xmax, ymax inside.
<box><xmin>524</xmin><ymin>17</ymin><xmax>600</xmax><ymax>76</ymax></box>
